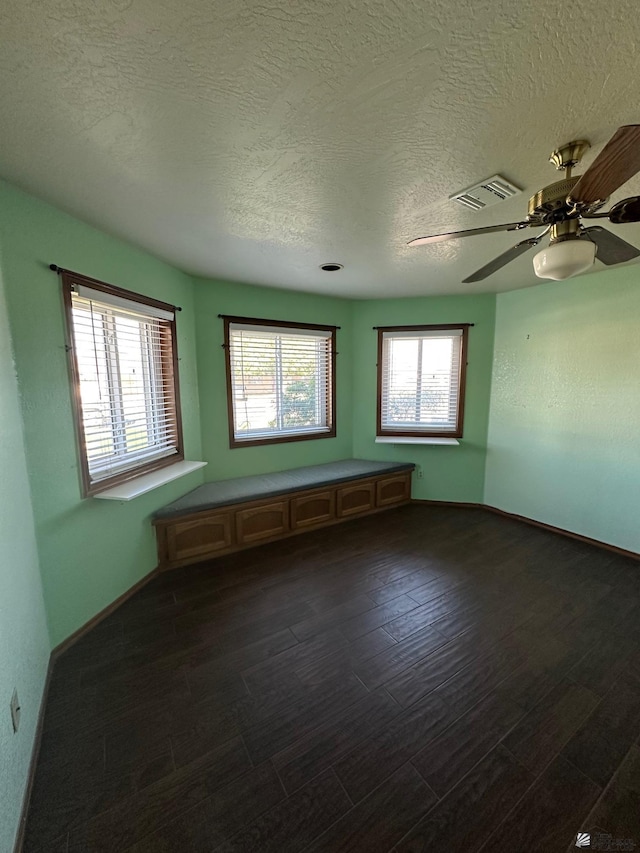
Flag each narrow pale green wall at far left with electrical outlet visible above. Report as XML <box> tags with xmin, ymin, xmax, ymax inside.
<box><xmin>0</xmin><ymin>246</ymin><xmax>49</xmax><ymax>851</ymax></box>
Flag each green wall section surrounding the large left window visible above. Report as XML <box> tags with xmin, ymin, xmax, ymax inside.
<box><xmin>0</xmin><ymin>184</ymin><xmax>203</xmax><ymax>646</ymax></box>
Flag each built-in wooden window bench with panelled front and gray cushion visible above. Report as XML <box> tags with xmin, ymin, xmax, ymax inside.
<box><xmin>153</xmin><ymin>459</ymin><xmax>415</xmax><ymax>569</ymax></box>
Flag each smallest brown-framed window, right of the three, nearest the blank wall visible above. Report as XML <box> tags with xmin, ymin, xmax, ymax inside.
<box><xmin>377</xmin><ymin>324</ymin><xmax>468</xmax><ymax>438</ymax></box>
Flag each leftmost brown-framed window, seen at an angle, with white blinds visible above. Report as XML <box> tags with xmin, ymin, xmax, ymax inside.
<box><xmin>61</xmin><ymin>271</ymin><xmax>184</xmax><ymax>496</ymax></box>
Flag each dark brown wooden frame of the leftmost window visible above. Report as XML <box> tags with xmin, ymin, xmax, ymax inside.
<box><xmin>58</xmin><ymin>269</ymin><xmax>184</xmax><ymax>498</ymax></box>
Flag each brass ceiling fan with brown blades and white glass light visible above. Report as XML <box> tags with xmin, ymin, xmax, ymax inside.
<box><xmin>408</xmin><ymin>124</ymin><xmax>640</xmax><ymax>284</ymax></box>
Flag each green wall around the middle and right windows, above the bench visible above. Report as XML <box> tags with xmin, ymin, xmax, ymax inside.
<box><xmin>196</xmin><ymin>279</ymin><xmax>495</xmax><ymax>502</ymax></box>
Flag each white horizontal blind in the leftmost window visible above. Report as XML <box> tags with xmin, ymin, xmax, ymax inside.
<box><xmin>71</xmin><ymin>288</ymin><xmax>179</xmax><ymax>484</ymax></box>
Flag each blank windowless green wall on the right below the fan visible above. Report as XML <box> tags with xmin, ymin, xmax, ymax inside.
<box><xmin>485</xmin><ymin>267</ymin><xmax>640</xmax><ymax>552</ymax></box>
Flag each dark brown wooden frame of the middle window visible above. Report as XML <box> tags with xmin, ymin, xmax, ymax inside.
<box><xmin>218</xmin><ymin>314</ymin><xmax>339</xmax><ymax>450</ymax></box>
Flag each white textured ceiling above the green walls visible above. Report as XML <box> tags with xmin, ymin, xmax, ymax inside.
<box><xmin>0</xmin><ymin>0</ymin><xmax>640</xmax><ymax>297</ymax></box>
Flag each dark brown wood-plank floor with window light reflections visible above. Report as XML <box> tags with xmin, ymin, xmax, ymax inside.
<box><xmin>24</xmin><ymin>504</ymin><xmax>640</xmax><ymax>853</ymax></box>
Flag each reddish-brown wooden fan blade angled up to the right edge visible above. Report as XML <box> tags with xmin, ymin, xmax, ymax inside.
<box><xmin>571</xmin><ymin>124</ymin><xmax>640</xmax><ymax>204</ymax></box>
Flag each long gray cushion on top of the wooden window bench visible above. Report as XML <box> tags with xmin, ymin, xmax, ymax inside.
<box><xmin>153</xmin><ymin>459</ymin><xmax>415</xmax><ymax>519</ymax></box>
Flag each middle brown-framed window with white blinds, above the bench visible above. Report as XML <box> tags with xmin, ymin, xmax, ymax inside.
<box><xmin>224</xmin><ymin>317</ymin><xmax>336</xmax><ymax>447</ymax></box>
